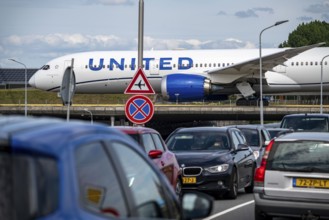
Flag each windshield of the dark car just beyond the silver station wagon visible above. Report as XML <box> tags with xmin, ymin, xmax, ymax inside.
<box><xmin>281</xmin><ymin>116</ymin><xmax>329</xmax><ymax>132</ymax></box>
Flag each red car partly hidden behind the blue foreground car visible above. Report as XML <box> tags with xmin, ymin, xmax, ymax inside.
<box><xmin>116</xmin><ymin>126</ymin><xmax>182</xmax><ymax>196</ymax></box>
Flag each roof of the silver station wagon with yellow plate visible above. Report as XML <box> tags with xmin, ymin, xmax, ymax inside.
<box><xmin>275</xmin><ymin>132</ymin><xmax>329</xmax><ymax>141</ymax></box>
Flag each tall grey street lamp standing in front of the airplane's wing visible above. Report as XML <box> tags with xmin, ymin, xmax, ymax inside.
<box><xmin>259</xmin><ymin>20</ymin><xmax>288</xmax><ymax>125</ymax></box>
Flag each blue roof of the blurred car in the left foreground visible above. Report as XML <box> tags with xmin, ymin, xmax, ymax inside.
<box><xmin>0</xmin><ymin>116</ymin><xmax>128</xmax><ymax>156</ymax></box>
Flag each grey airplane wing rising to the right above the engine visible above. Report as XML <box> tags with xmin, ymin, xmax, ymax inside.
<box><xmin>208</xmin><ymin>43</ymin><xmax>325</xmax><ymax>84</ymax></box>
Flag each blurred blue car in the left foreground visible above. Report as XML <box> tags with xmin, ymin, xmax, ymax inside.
<box><xmin>0</xmin><ymin>116</ymin><xmax>212</xmax><ymax>220</ymax></box>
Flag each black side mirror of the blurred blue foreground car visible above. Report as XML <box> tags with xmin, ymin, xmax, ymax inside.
<box><xmin>182</xmin><ymin>192</ymin><xmax>214</xmax><ymax>220</ymax></box>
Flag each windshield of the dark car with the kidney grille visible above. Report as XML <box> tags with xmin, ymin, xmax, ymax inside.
<box><xmin>167</xmin><ymin>131</ymin><xmax>229</xmax><ymax>151</ymax></box>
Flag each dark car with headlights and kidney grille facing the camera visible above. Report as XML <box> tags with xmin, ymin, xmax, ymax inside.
<box><xmin>166</xmin><ymin>127</ymin><xmax>256</xmax><ymax>199</ymax></box>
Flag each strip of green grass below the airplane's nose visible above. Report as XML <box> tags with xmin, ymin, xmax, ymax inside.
<box><xmin>0</xmin><ymin>89</ymin><xmax>135</xmax><ymax>104</ymax></box>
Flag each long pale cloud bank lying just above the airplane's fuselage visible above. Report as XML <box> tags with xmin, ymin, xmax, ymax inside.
<box><xmin>0</xmin><ymin>33</ymin><xmax>255</xmax><ymax>68</ymax></box>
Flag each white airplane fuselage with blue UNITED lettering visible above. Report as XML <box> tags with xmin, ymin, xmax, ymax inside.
<box><xmin>29</xmin><ymin>47</ymin><xmax>329</xmax><ymax>99</ymax></box>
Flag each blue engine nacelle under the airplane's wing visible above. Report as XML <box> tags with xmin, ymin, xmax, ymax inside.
<box><xmin>161</xmin><ymin>74</ymin><xmax>211</xmax><ymax>101</ymax></box>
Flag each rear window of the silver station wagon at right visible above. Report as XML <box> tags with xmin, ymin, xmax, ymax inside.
<box><xmin>268</xmin><ymin>141</ymin><xmax>329</xmax><ymax>173</ymax></box>
